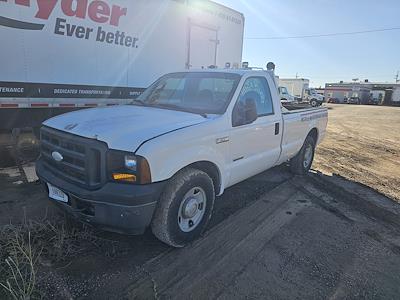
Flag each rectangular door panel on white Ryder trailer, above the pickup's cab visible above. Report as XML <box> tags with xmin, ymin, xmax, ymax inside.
<box><xmin>186</xmin><ymin>23</ymin><xmax>219</xmax><ymax>69</ymax></box>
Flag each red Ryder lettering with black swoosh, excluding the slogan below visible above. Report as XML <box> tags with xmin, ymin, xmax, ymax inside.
<box><xmin>0</xmin><ymin>0</ymin><xmax>127</xmax><ymax>30</ymax></box>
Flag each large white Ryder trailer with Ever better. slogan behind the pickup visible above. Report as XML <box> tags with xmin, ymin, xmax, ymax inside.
<box><xmin>0</xmin><ymin>0</ymin><xmax>244</xmax><ymax>162</ymax></box>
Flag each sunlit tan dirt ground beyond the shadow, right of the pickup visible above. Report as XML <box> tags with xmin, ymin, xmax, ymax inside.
<box><xmin>313</xmin><ymin>104</ymin><xmax>400</xmax><ymax>202</ymax></box>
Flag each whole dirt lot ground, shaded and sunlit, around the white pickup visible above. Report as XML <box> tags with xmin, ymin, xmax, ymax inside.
<box><xmin>0</xmin><ymin>105</ymin><xmax>400</xmax><ymax>299</ymax></box>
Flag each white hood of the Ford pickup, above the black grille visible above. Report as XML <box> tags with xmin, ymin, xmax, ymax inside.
<box><xmin>43</xmin><ymin>105</ymin><xmax>208</xmax><ymax>152</ymax></box>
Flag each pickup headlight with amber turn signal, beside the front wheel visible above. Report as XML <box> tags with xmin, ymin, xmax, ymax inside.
<box><xmin>107</xmin><ymin>150</ymin><xmax>151</xmax><ymax>184</ymax></box>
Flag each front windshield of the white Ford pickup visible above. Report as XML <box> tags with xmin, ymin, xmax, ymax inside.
<box><xmin>134</xmin><ymin>72</ymin><xmax>241</xmax><ymax>114</ymax></box>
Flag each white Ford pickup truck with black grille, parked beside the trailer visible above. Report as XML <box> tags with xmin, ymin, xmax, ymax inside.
<box><xmin>36</xmin><ymin>69</ymin><xmax>328</xmax><ymax>247</ymax></box>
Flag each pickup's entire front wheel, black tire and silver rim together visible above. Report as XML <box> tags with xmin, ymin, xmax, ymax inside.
<box><xmin>151</xmin><ymin>168</ymin><xmax>215</xmax><ymax>247</ymax></box>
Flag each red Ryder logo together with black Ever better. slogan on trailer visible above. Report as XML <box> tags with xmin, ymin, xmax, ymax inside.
<box><xmin>0</xmin><ymin>0</ymin><xmax>139</xmax><ymax>48</ymax></box>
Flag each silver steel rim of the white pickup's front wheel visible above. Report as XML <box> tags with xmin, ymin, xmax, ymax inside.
<box><xmin>178</xmin><ymin>187</ymin><xmax>206</xmax><ymax>232</ymax></box>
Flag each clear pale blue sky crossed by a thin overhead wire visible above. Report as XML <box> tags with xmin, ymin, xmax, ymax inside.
<box><xmin>215</xmin><ymin>0</ymin><xmax>400</xmax><ymax>87</ymax></box>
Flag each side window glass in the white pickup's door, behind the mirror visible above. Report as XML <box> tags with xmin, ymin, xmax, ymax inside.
<box><xmin>238</xmin><ymin>77</ymin><xmax>274</xmax><ymax>117</ymax></box>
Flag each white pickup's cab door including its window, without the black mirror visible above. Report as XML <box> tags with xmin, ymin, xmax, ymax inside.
<box><xmin>229</xmin><ymin>76</ymin><xmax>282</xmax><ymax>186</ymax></box>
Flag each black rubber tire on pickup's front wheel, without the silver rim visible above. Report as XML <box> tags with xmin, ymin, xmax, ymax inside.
<box><xmin>151</xmin><ymin>168</ymin><xmax>215</xmax><ymax>247</ymax></box>
